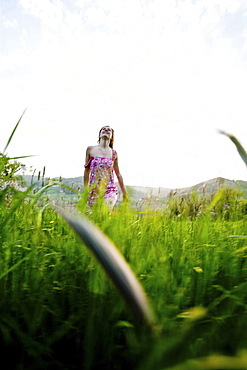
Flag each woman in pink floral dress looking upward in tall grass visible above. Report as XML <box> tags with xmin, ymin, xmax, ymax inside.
<box><xmin>84</xmin><ymin>126</ymin><xmax>127</xmax><ymax>211</ymax></box>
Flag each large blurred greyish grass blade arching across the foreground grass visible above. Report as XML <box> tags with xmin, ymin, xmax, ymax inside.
<box><xmin>58</xmin><ymin>210</ymin><xmax>155</xmax><ymax>326</ymax></box>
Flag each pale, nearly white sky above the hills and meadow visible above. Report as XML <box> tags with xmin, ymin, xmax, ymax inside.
<box><xmin>0</xmin><ymin>0</ymin><xmax>247</xmax><ymax>188</ymax></box>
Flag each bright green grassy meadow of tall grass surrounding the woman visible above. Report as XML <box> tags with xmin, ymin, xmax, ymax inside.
<box><xmin>0</xmin><ymin>120</ymin><xmax>247</xmax><ymax>370</ymax></box>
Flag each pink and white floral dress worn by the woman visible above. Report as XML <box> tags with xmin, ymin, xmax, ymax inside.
<box><xmin>84</xmin><ymin>150</ymin><xmax>118</xmax><ymax>207</ymax></box>
